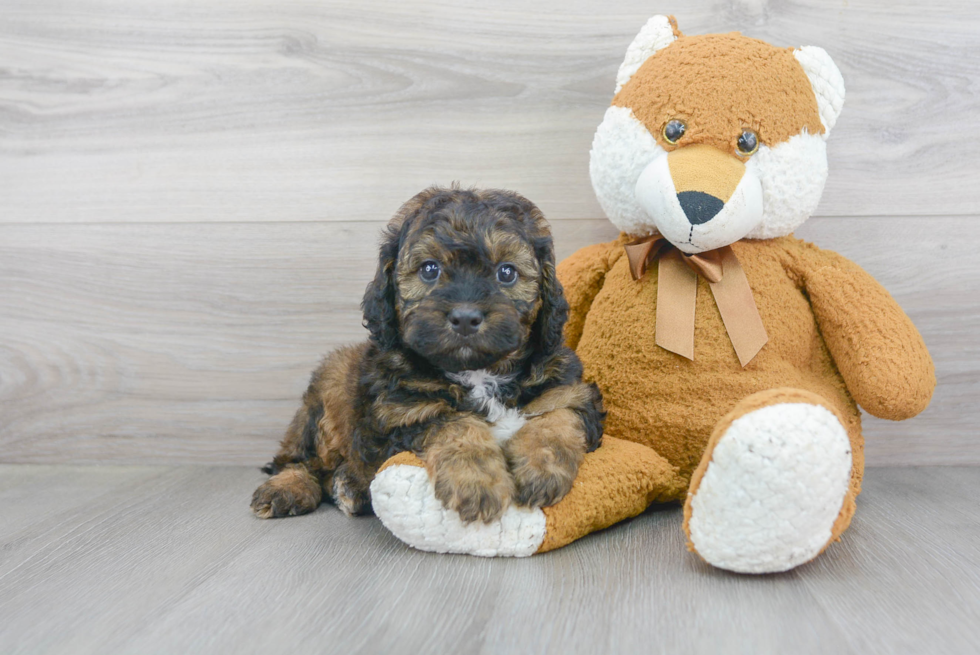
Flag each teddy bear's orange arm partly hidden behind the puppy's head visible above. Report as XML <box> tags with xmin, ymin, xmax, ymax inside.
<box><xmin>557</xmin><ymin>241</ymin><xmax>623</xmax><ymax>350</ymax></box>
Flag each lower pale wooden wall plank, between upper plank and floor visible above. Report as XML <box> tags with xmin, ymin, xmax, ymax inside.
<box><xmin>0</xmin><ymin>217</ymin><xmax>980</xmax><ymax>465</ymax></box>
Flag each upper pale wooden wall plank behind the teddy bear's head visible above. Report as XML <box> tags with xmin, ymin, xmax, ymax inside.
<box><xmin>0</xmin><ymin>0</ymin><xmax>980</xmax><ymax>223</ymax></box>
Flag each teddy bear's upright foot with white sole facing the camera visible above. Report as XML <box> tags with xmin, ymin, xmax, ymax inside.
<box><xmin>684</xmin><ymin>389</ymin><xmax>856</xmax><ymax>573</ymax></box>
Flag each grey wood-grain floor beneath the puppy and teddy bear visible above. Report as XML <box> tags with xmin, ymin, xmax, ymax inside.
<box><xmin>0</xmin><ymin>465</ymin><xmax>980</xmax><ymax>654</ymax></box>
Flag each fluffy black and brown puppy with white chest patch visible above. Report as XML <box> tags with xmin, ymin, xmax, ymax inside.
<box><xmin>252</xmin><ymin>187</ymin><xmax>605</xmax><ymax>522</ymax></box>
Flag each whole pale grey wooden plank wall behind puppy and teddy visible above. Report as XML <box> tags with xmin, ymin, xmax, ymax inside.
<box><xmin>0</xmin><ymin>0</ymin><xmax>980</xmax><ymax>465</ymax></box>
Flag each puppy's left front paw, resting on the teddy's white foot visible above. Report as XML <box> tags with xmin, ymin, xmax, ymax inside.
<box><xmin>433</xmin><ymin>457</ymin><xmax>514</xmax><ymax>523</ymax></box>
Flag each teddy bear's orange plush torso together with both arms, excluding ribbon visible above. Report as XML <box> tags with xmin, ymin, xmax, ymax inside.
<box><xmin>556</xmin><ymin>235</ymin><xmax>936</xmax><ymax>552</ymax></box>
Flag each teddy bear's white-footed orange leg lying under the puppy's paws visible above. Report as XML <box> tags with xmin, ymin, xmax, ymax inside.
<box><xmin>371</xmin><ymin>436</ymin><xmax>687</xmax><ymax>557</ymax></box>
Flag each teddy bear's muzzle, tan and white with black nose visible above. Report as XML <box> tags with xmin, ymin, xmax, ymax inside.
<box><xmin>635</xmin><ymin>144</ymin><xmax>763</xmax><ymax>255</ymax></box>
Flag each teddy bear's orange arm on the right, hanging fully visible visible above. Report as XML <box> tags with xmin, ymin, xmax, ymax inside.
<box><xmin>804</xmin><ymin>251</ymin><xmax>936</xmax><ymax>421</ymax></box>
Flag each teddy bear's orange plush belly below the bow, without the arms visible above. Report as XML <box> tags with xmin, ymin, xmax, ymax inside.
<box><xmin>576</xmin><ymin>254</ymin><xmax>861</xmax><ymax>490</ymax></box>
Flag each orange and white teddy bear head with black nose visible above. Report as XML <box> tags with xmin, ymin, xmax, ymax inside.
<box><xmin>589</xmin><ymin>16</ymin><xmax>844</xmax><ymax>254</ymax></box>
